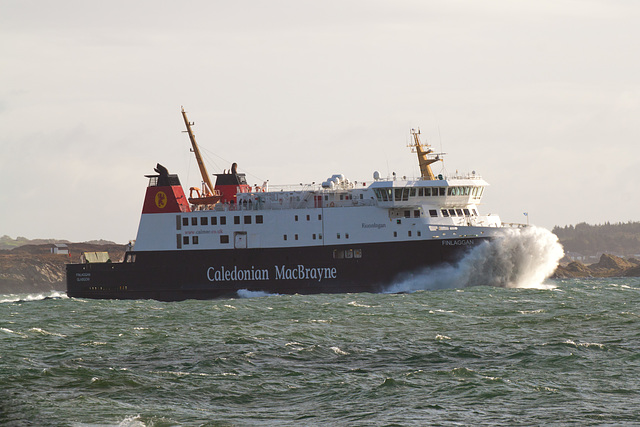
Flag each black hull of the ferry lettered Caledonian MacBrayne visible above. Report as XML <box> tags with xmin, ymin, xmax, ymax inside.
<box><xmin>67</xmin><ymin>237</ymin><xmax>486</xmax><ymax>301</ymax></box>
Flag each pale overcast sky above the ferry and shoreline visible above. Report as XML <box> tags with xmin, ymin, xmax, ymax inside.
<box><xmin>0</xmin><ymin>0</ymin><xmax>640</xmax><ymax>243</ymax></box>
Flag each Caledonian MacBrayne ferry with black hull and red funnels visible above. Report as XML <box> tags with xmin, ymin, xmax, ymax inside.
<box><xmin>67</xmin><ymin>108</ymin><xmax>509</xmax><ymax>301</ymax></box>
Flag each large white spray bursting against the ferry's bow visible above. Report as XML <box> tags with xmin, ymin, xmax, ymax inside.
<box><xmin>387</xmin><ymin>227</ymin><xmax>564</xmax><ymax>292</ymax></box>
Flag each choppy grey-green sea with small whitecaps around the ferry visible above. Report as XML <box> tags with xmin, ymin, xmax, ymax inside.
<box><xmin>0</xmin><ymin>227</ymin><xmax>640</xmax><ymax>426</ymax></box>
